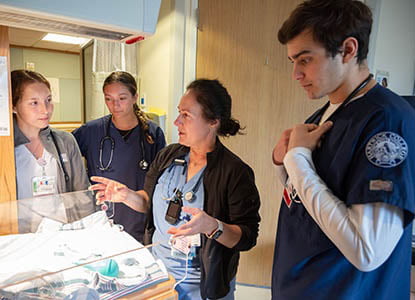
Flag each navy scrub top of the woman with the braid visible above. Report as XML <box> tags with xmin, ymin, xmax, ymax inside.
<box><xmin>73</xmin><ymin>115</ymin><xmax>166</xmax><ymax>241</ymax></box>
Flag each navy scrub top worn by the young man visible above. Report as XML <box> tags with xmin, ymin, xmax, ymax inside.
<box><xmin>272</xmin><ymin>85</ymin><xmax>415</xmax><ymax>299</ymax></box>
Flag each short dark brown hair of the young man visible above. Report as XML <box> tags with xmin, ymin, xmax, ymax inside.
<box><xmin>278</xmin><ymin>0</ymin><xmax>372</xmax><ymax>64</ymax></box>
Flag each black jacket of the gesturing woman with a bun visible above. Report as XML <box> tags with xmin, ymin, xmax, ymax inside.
<box><xmin>144</xmin><ymin>139</ymin><xmax>260</xmax><ymax>299</ymax></box>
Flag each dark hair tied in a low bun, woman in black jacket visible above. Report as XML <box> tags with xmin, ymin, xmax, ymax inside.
<box><xmin>187</xmin><ymin>79</ymin><xmax>241</xmax><ymax>136</ymax></box>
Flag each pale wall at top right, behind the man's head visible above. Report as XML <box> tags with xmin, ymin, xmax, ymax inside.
<box><xmin>369</xmin><ymin>0</ymin><xmax>415</xmax><ymax>95</ymax></box>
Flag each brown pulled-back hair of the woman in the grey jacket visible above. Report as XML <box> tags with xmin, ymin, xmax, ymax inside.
<box><xmin>10</xmin><ymin>70</ymin><xmax>50</xmax><ymax>107</ymax></box>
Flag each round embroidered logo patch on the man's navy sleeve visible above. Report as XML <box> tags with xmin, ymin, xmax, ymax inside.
<box><xmin>366</xmin><ymin>131</ymin><xmax>408</xmax><ymax>168</ymax></box>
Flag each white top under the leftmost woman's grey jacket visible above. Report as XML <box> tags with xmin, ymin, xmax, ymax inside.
<box><xmin>14</xmin><ymin>145</ymin><xmax>58</xmax><ymax>199</ymax></box>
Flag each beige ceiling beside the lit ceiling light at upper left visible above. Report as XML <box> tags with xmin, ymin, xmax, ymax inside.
<box><xmin>9</xmin><ymin>27</ymin><xmax>81</xmax><ymax>53</ymax></box>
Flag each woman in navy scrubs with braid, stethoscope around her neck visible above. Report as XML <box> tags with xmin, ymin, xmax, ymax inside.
<box><xmin>73</xmin><ymin>71</ymin><xmax>166</xmax><ymax>241</ymax></box>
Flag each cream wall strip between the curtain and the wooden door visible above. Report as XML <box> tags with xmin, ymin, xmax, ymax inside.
<box><xmin>138</xmin><ymin>0</ymin><xmax>197</xmax><ymax>143</ymax></box>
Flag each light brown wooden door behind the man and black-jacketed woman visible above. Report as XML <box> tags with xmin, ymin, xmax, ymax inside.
<box><xmin>196</xmin><ymin>0</ymin><xmax>322</xmax><ymax>286</ymax></box>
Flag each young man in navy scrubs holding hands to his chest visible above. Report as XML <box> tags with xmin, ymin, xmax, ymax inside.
<box><xmin>272</xmin><ymin>0</ymin><xmax>415</xmax><ymax>300</ymax></box>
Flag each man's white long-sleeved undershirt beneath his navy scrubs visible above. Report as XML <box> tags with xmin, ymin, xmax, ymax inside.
<box><xmin>277</xmin><ymin>96</ymin><xmax>403</xmax><ymax>272</ymax></box>
